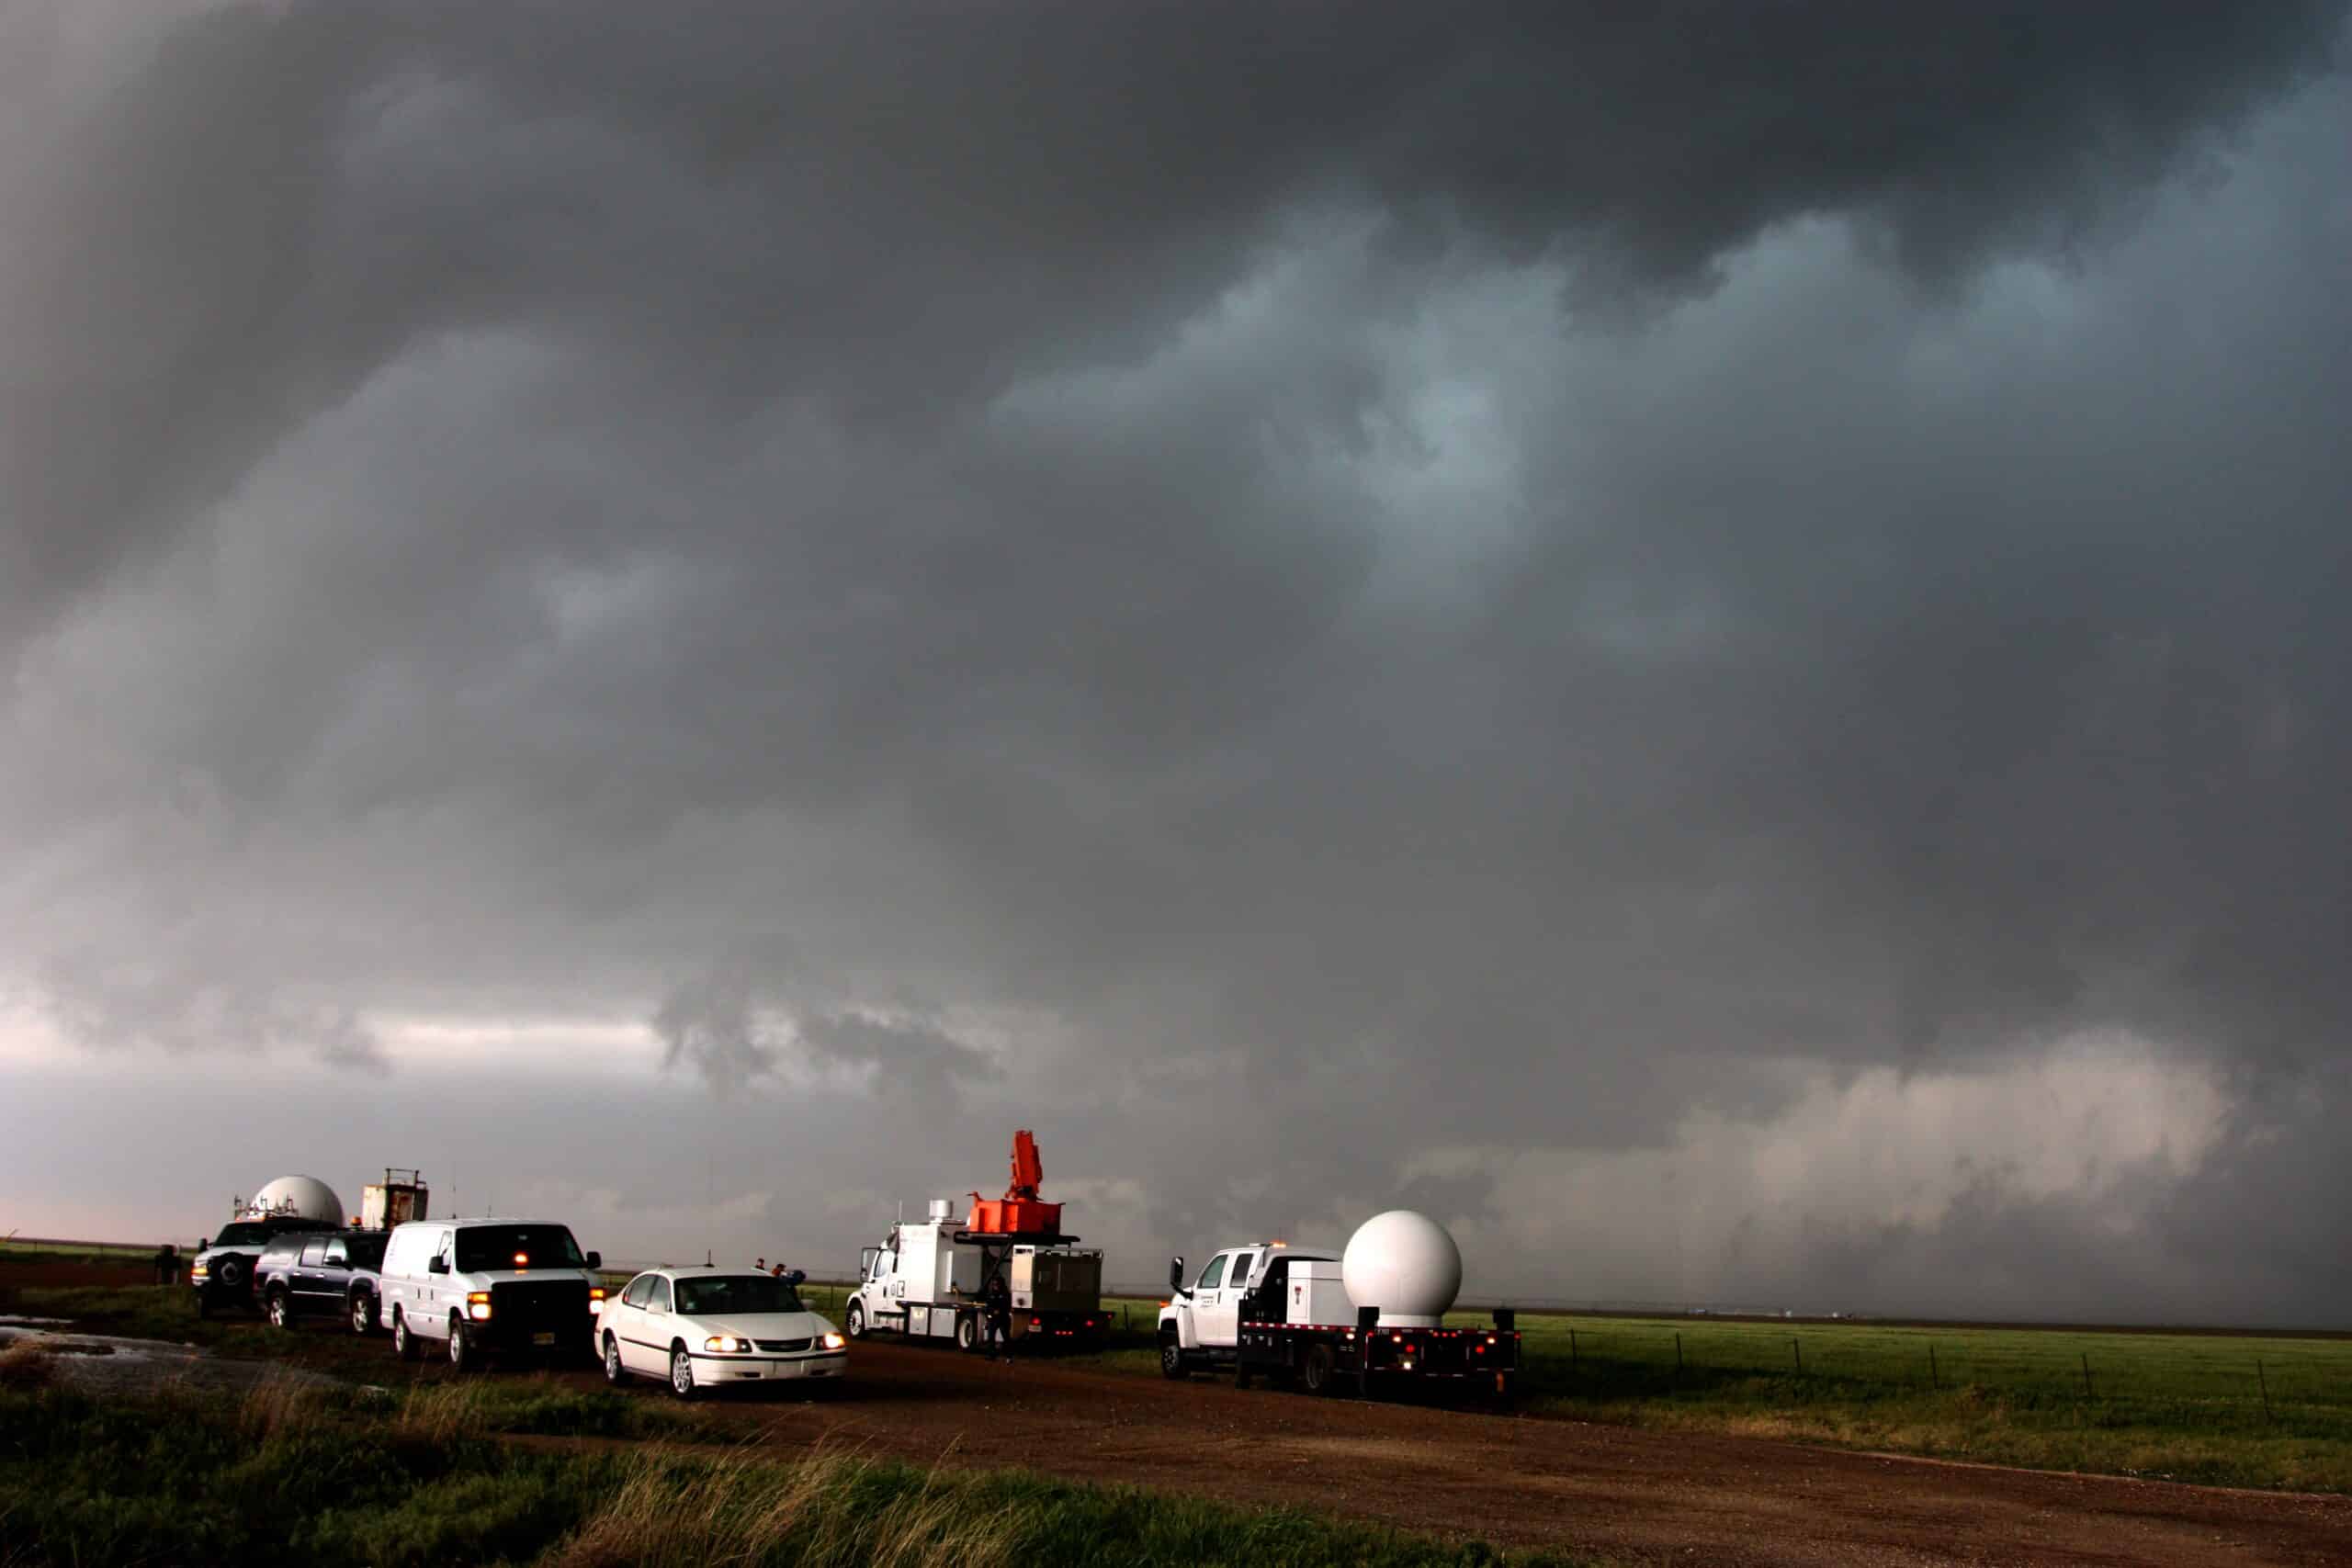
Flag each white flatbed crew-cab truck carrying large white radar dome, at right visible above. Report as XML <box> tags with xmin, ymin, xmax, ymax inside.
<box><xmin>1159</xmin><ymin>1208</ymin><xmax>1520</xmax><ymax>1404</ymax></box>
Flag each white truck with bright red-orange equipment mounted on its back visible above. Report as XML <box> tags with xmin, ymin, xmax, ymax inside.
<box><xmin>842</xmin><ymin>1131</ymin><xmax>1105</xmax><ymax>1352</ymax></box>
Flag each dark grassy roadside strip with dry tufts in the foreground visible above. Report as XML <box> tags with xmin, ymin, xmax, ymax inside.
<box><xmin>0</xmin><ymin>1352</ymin><xmax>1599</xmax><ymax>1568</ymax></box>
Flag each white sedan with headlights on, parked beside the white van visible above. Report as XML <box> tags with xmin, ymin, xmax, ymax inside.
<box><xmin>595</xmin><ymin>1267</ymin><xmax>849</xmax><ymax>1399</ymax></box>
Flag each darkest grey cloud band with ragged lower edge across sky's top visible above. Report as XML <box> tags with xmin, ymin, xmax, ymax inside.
<box><xmin>0</xmin><ymin>3</ymin><xmax>2343</xmax><ymax>639</ymax></box>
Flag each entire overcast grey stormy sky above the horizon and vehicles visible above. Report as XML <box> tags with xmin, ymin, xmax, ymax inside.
<box><xmin>0</xmin><ymin>0</ymin><xmax>2352</xmax><ymax>1325</ymax></box>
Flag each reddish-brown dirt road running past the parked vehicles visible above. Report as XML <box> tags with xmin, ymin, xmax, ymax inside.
<box><xmin>545</xmin><ymin>1342</ymin><xmax>2352</xmax><ymax>1565</ymax></box>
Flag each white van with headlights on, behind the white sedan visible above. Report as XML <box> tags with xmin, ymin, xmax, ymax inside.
<box><xmin>377</xmin><ymin>1220</ymin><xmax>605</xmax><ymax>1371</ymax></box>
